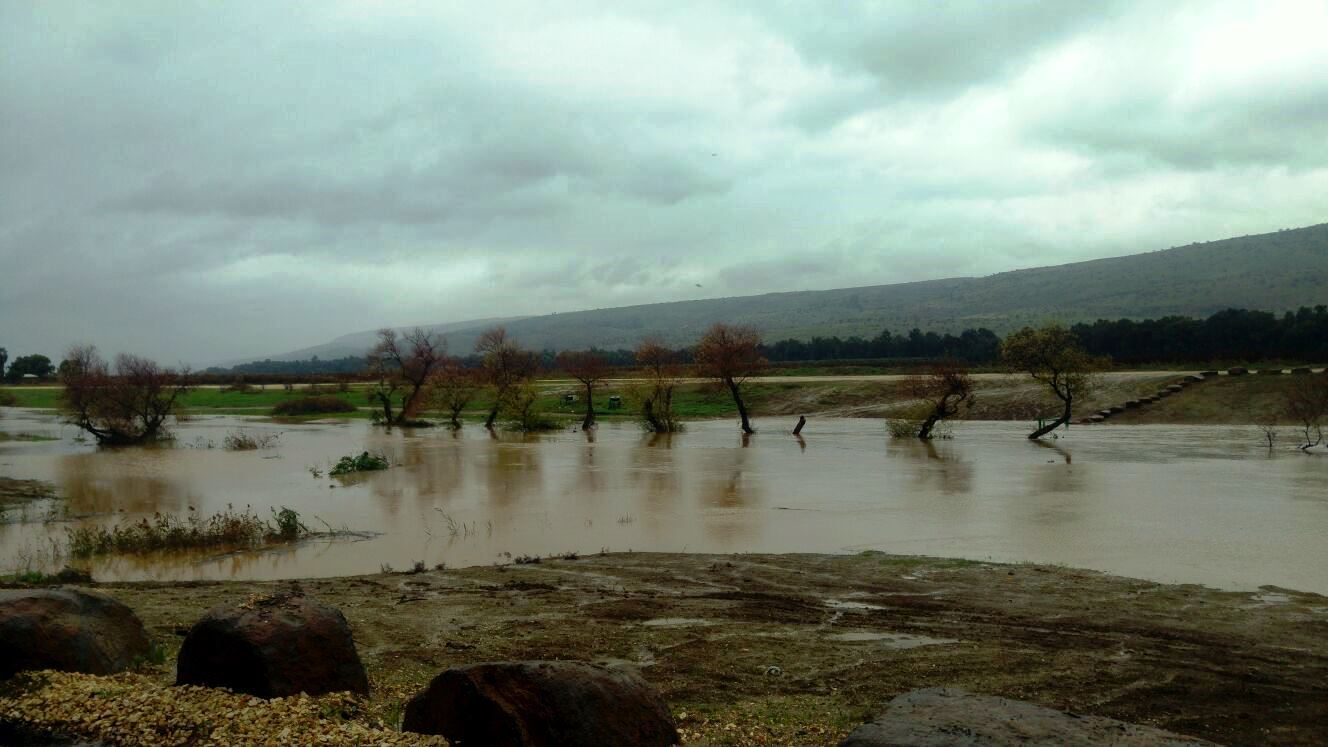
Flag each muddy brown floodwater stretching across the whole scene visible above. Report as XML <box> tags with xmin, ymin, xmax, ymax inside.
<box><xmin>0</xmin><ymin>409</ymin><xmax>1328</xmax><ymax>593</ymax></box>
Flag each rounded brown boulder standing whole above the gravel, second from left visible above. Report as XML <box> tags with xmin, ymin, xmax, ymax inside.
<box><xmin>175</xmin><ymin>593</ymin><xmax>369</xmax><ymax>698</ymax></box>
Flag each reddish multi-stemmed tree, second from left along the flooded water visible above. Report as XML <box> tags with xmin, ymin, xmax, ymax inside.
<box><xmin>369</xmin><ymin>327</ymin><xmax>448</xmax><ymax>425</ymax></box>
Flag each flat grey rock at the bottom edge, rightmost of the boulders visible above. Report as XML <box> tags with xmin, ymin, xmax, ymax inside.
<box><xmin>839</xmin><ymin>687</ymin><xmax>1211</xmax><ymax>747</ymax></box>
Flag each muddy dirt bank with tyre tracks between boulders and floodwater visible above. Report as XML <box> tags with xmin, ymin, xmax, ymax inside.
<box><xmin>0</xmin><ymin>554</ymin><xmax>1328</xmax><ymax>744</ymax></box>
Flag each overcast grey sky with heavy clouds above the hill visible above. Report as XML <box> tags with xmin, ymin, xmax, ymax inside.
<box><xmin>0</xmin><ymin>0</ymin><xmax>1328</xmax><ymax>364</ymax></box>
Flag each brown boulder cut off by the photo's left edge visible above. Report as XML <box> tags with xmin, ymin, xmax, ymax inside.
<box><xmin>0</xmin><ymin>589</ymin><xmax>151</xmax><ymax>679</ymax></box>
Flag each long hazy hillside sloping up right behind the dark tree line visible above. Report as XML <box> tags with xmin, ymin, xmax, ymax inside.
<box><xmin>253</xmin><ymin>223</ymin><xmax>1328</xmax><ymax>360</ymax></box>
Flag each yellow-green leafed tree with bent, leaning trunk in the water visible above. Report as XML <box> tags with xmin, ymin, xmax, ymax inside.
<box><xmin>1001</xmin><ymin>324</ymin><xmax>1109</xmax><ymax>440</ymax></box>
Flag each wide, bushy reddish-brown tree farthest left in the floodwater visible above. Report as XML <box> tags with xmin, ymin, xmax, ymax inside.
<box><xmin>61</xmin><ymin>346</ymin><xmax>191</xmax><ymax>445</ymax></box>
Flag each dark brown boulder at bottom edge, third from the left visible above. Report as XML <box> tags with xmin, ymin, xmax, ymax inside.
<box><xmin>402</xmin><ymin>662</ymin><xmax>679</xmax><ymax>747</ymax></box>
